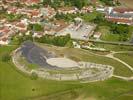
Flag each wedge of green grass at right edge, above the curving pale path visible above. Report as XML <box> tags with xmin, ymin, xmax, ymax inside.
<box><xmin>114</xmin><ymin>53</ymin><xmax>133</xmax><ymax>67</ymax></box>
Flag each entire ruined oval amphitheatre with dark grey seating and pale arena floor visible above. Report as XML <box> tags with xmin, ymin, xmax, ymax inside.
<box><xmin>12</xmin><ymin>41</ymin><xmax>114</xmax><ymax>82</ymax></box>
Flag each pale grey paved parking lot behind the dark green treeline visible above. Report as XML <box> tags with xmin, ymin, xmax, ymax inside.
<box><xmin>56</xmin><ymin>23</ymin><xmax>95</xmax><ymax>40</ymax></box>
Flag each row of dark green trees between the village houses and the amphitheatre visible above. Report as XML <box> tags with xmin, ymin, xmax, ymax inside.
<box><xmin>11</xmin><ymin>34</ymin><xmax>73</xmax><ymax>47</ymax></box>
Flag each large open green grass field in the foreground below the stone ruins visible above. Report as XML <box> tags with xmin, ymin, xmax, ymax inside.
<box><xmin>0</xmin><ymin>46</ymin><xmax>133</xmax><ymax>100</ymax></box>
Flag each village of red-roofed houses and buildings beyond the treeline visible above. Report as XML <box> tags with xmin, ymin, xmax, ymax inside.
<box><xmin>0</xmin><ymin>0</ymin><xmax>133</xmax><ymax>45</ymax></box>
